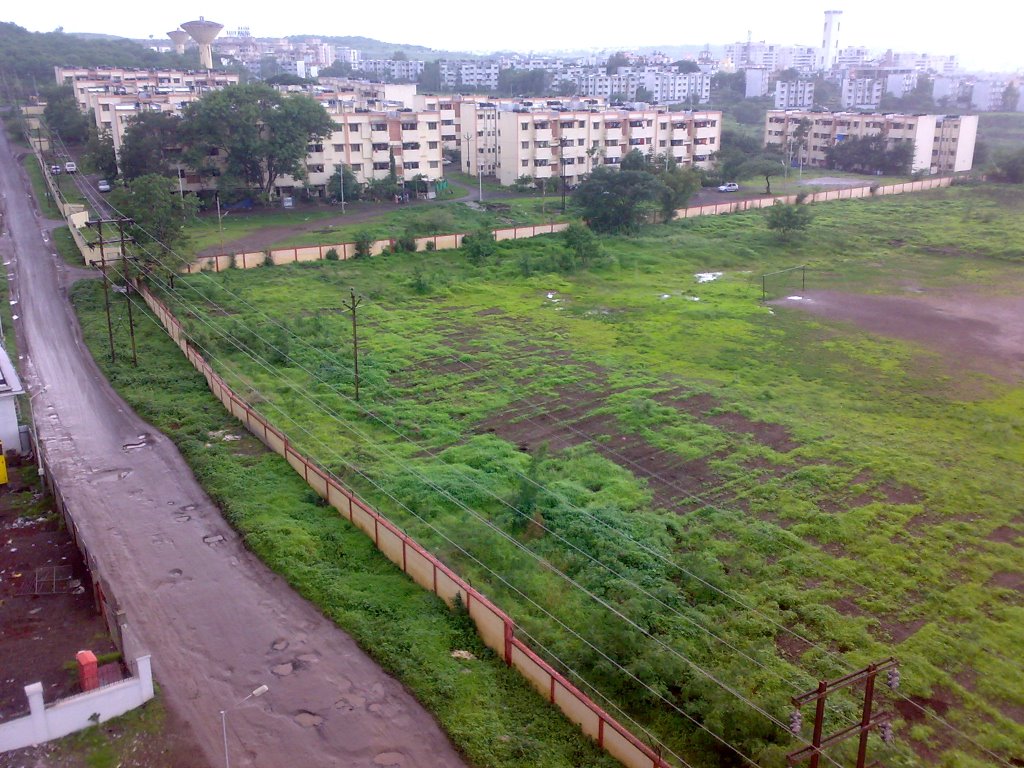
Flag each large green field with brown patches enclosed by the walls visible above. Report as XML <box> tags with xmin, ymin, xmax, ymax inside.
<box><xmin>75</xmin><ymin>187</ymin><xmax>1024</xmax><ymax>767</ymax></box>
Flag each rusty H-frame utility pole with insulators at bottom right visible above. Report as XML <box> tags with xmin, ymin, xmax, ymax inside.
<box><xmin>785</xmin><ymin>657</ymin><xmax>899</xmax><ymax>768</ymax></box>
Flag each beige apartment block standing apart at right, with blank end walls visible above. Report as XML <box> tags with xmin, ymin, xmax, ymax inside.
<box><xmin>765</xmin><ymin>110</ymin><xmax>978</xmax><ymax>173</ymax></box>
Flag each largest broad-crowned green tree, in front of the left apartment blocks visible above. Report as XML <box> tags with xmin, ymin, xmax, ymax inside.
<box><xmin>182</xmin><ymin>83</ymin><xmax>334</xmax><ymax>196</ymax></box>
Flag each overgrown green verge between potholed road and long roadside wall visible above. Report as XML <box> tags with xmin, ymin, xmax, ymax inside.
<box><xmin>73</xmin><ymin>283</ymin><xmax>615</xmax><ymax>768</ymax></box>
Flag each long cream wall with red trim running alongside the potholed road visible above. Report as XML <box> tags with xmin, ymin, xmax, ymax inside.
<box><xmin>136</xmin><ymin>282</ymin><xmax>669</xmax><ymax>768</ymax></box>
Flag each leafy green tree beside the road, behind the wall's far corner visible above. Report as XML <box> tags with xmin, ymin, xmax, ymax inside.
<box><xmin>111</xmin><ymin>174</ymin><xmax>199</xmax><ymax>268</ymax></box>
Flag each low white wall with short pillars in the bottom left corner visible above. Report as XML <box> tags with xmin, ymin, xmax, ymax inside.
<box><xmin>0</xmin><ymin>656</ymin><xmax>154</xmax><ymax>753</ymax></box>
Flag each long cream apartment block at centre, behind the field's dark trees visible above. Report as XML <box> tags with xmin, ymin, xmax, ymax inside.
<box><xmin>462</xmin><ymin>105</ymin><xmax>722</xmax><ymax>185</ymax></box>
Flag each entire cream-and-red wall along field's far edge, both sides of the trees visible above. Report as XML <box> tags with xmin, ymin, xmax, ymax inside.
<box><xmin>182</xmin><ymin>174</ymin><xmax>952</xmax><ymax>274</ymax></box>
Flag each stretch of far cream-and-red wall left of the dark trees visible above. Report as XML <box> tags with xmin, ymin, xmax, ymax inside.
<box><xmin>185</xmin><ymin>223</ymin><xmax>568</xmax><ymax>274</ymax></box>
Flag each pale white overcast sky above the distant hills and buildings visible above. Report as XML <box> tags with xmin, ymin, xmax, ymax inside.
<box><xmin>6</xmin><ymin>0</ymin><xmax>1024</xmax><ymax>72</ymax></box>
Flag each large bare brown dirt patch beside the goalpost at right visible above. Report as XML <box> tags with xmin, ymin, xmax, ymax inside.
<box><xmin>770</xmin><ymin>291</ymin><xmax>1024</xmax><ymax>383</ymax></box>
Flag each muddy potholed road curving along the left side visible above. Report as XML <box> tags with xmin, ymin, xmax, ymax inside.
<box><xmin>0</xmin><ymin>132</ymin><xmax>464</xmax><ymax>768</ymax></box>
